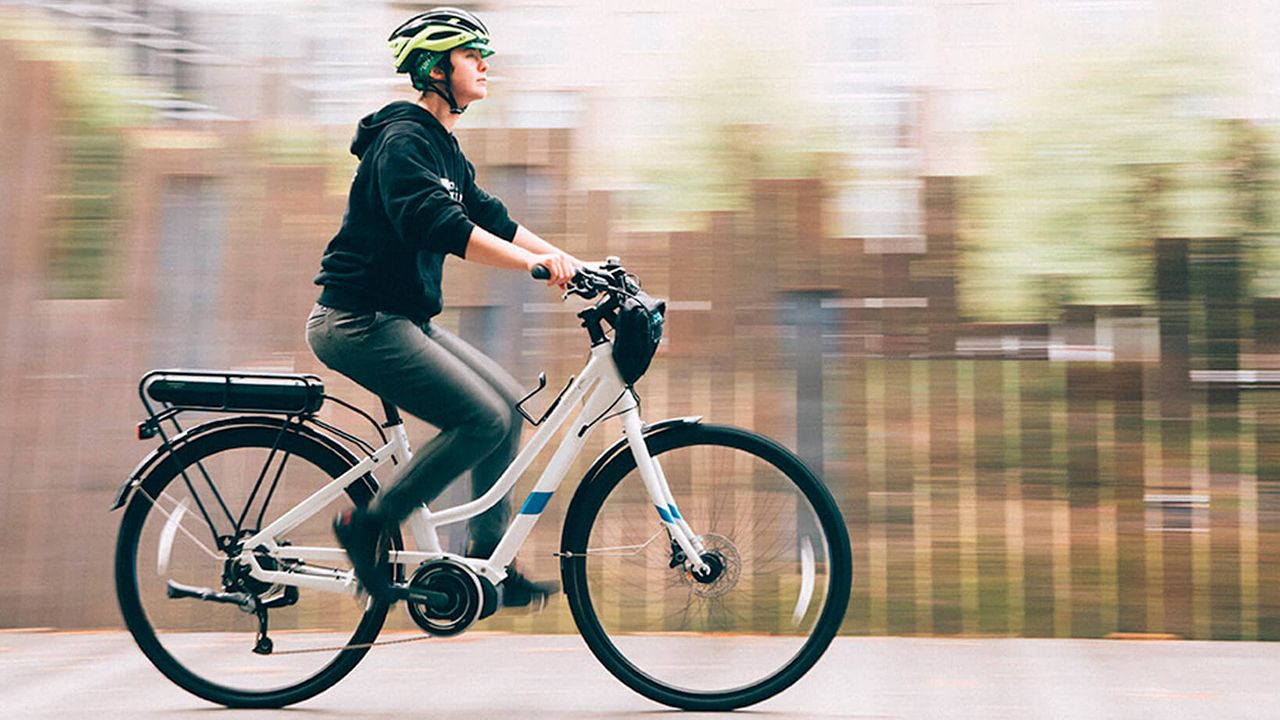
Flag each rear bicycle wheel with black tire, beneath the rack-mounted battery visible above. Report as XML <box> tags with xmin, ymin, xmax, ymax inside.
<box><xmin>116</xmin><ymin>423</ymin><xmax>401</xmax><ymax>707</ymax></box>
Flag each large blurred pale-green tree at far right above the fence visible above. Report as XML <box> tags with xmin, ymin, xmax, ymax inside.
<box><xmin>960</xmin><ymin>44</ymin><xmax>1277</xmax><ymax>320</ymax></box>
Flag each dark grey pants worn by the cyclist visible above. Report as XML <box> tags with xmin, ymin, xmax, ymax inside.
<box><xmin>307</xmin><ymin>299</ymin><xmax>522</xmax><ymax>556</ymax></box>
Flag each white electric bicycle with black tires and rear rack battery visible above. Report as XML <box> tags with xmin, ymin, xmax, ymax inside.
<box><xmin>111</xmin><ymin>258</ymin><xmax>852</xmax><ymax>710</ymax></box>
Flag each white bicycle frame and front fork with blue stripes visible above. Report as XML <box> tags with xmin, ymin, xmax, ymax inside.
<box><xmin>241</xmin><ymin>342</ymin><xmax>707</xmax><ymax>593</ymax></box>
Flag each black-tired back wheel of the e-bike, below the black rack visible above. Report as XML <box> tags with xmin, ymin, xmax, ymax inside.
<box><xmin>115</xmin><ymin>419</ymin><xmax>402</xmax><ymax>707</ymax></box>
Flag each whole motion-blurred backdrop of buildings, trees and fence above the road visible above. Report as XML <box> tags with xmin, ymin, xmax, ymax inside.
<box><xmin>0</xmin><ymin>0</ymin><xmax>1280</xmax><ymax>639</ymax></box>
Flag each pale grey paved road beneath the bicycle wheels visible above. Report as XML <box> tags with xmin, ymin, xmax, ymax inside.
<box><xmin>0</xmin><ymin>632</ymin><xmax>1280</xmax><ymax>720</ymax></box>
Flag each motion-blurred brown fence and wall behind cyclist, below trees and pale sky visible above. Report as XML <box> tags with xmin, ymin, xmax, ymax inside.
<box><xmin>0</xmin><ymin>44</ymin><xmax>1280</xmax><ymax>639</ymax></box>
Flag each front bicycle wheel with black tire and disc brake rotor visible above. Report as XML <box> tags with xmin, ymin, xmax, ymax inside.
<box><xmin>561</xmin><ymin>425</ymin><xmax>852</xmax><ymax>711</ymax></box>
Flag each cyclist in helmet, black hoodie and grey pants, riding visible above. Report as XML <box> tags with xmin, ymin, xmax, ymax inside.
<box><xmin>306</xmin><ymin>8</ymin><xmax>581</xmax><ymax>606</ymax></box>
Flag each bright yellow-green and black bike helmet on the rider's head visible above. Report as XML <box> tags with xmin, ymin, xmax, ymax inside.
<box><xmin>387</xmin><ymin>8</ymin><xmax>493</xmax><ymax>97</ymax></box>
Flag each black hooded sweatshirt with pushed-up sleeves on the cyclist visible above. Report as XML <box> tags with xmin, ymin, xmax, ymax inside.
<box><xmin>315</xmin><ymin>101</ymin><xmax>517</xmax><ymax>322</ymax></box>
